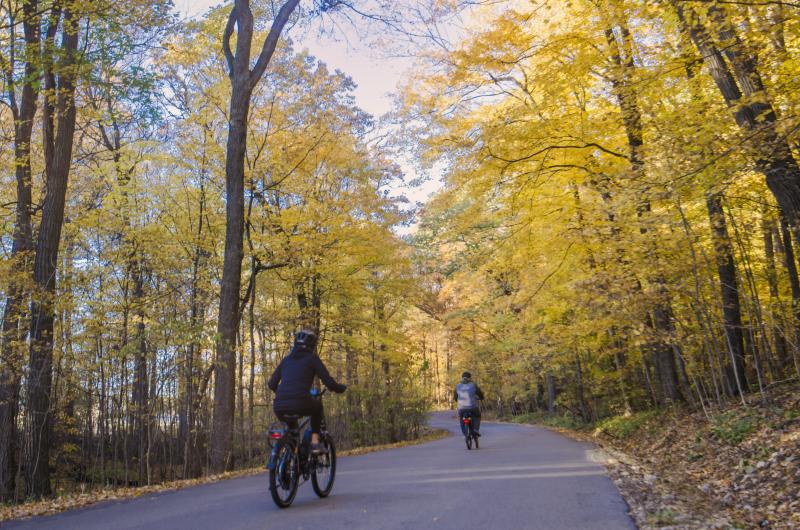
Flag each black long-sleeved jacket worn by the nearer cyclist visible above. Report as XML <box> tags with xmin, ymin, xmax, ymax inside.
<box><xmin>268</xmin><ymin>347</ymin><xmax>347</xmax><ymax>411</ymax></box>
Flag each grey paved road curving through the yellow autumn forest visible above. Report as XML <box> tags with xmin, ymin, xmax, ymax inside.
<box><xmin>0</xmin><ymin>413</ymin><xmax>635</xmax><ymax>530</ymax></box>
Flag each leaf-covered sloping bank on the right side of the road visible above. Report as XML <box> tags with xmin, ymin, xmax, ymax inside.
<box><xmin>506</xmin><ymin>385</ymin><xmax>800</xmax><ymax>529</ymax></box>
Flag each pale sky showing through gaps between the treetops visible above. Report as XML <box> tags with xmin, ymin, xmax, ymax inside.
<box><xmin>174</xmin><ymin>0</ymin><xmax>441</xmax><ymax>214</ymax></box>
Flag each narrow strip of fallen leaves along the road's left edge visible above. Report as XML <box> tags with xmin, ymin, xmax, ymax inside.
<box><xmin>0</xmin><ymin>428</ymin><xmax>448</xmax><ymax>522</ymax></box>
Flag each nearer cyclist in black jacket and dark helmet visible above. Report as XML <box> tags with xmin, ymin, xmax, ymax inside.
<box><xmin>268</xmin><ymin>329</ymin><xmax>347</xmax><ymax>453</ymax></box>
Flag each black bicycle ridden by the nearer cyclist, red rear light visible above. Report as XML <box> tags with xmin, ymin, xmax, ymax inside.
<box><xmin>267</xmin><ymin>389</ymin><xmax>336</xmax><ymax>508</ymax></box>
